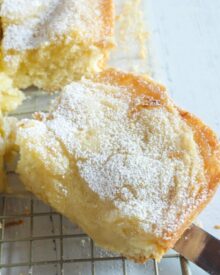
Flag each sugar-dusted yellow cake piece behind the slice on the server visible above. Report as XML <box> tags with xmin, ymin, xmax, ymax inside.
<box><xmin>0</xmin><ymin>0</ymin><xmax>114</xmax><ymax>91</ymax></box>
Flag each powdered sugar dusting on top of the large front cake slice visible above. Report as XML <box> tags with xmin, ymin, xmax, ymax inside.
<box><xmin>17</xmin><ymin>80</ymin><xmax>207</xmax><ymax>238</ymax></box>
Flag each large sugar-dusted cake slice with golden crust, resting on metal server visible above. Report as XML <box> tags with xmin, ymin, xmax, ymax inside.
<box><xmin>17</xmin><ymin>70</ymin><xmax>220</xmax><ymax>262</ymax></box>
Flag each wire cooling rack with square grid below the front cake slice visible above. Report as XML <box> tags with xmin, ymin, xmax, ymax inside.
<box><xmin>0</xmin><ymin>196</ymin><xmax>191</xmax><ymax>275</ymax></box>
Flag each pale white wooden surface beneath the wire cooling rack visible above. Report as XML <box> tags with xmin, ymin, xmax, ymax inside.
<box><xmin>0</xmin><ymin>0</ymin><xmax>220</xmax><ymax>275</ymax></box>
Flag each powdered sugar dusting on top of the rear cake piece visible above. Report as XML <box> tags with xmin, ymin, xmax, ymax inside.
<box><xmin>0</xmin><ymin>0</ymin><xmax>102</xmax><ymax>50</ymax></box>
